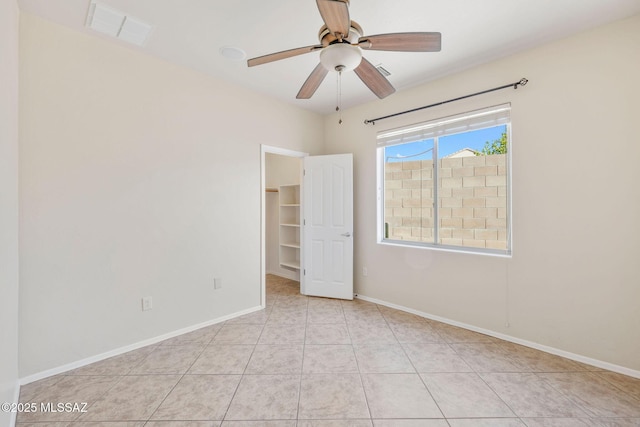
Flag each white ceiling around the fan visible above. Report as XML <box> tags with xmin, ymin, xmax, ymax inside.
<box><xmin>18</xmin><ymin>0</ymin><xmax>640</xmax><ymax>114</ymax></box>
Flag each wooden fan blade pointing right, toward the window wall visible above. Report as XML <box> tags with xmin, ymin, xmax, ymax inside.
<box><xmin>358</xmin><ymin>33</ymin><xmax>442</xmax><ymax>52</ymax></box>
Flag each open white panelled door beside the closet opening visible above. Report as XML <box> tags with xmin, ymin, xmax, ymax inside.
<box><xmin>300</xmin><ymin>154</ymin><xmax>353</xmax><ymax>299</ymax></box>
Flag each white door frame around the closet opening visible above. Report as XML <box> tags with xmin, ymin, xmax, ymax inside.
<box><xmin>260</xmin><ymin>144</ymin><xmax>309</xmax><ymax>308</ymax></box>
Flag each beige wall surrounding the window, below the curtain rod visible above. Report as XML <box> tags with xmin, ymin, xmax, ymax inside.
<box><xmin>325</xmin><ymin>16</ymin><xmax>640</xmax><ymax>372</ymax></box>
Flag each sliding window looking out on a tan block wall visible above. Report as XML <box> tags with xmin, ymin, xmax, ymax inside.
<box><xmin>377</xmin><ymin>105</ymin><xmax>511</xmax><ymax>255</ymax></box>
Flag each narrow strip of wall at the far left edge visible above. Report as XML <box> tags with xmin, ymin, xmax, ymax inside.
<box><xmin>0</xmin><ymin>0</ymin><xmax>19</xmax><ymax>425</ymax></box>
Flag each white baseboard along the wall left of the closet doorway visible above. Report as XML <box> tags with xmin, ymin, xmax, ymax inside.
<box><xmin>16</xmin><ymin>306</ymin><xmax>264</xmax><ymax>388</ymax></box>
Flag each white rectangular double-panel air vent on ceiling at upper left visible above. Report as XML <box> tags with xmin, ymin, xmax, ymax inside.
<box><xmin>87</xmin><ymin>2</ymin><xmax>151</xmax><ymax>46</ymax></box>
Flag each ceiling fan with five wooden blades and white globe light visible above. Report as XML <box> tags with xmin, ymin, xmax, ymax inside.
<box><xmin>247</xmin><ymin>0</ymin><xmax>441</xmax><ymax>99</ymax></box>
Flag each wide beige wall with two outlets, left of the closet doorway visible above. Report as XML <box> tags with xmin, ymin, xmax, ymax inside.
<box><xmin>20</xmin><ymin>14</ymin><xmax>323</xmax><ymax>377</ymax></box>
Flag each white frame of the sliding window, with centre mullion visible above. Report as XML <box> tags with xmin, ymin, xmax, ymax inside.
<box><xmin>376</xmin><ymin>104</ymin><xmax>513</xmax><ymax>257</ymax></box>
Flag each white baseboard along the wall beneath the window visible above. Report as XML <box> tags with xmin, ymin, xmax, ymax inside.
<box><xmin>355</xmin><ymin>294</ymin><xmax>640</xmax><ymax>378</ymax></box>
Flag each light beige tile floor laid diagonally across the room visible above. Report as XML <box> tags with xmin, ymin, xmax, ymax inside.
<box><xmin>13</xmin><ymin>276</ymin><xmax>640</xmax><ymax>427</ymax></box>
